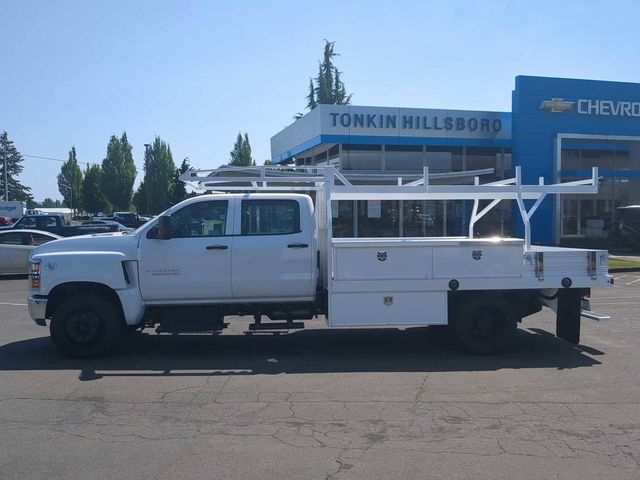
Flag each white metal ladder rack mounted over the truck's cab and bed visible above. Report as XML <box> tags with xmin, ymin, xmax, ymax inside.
<box><xmin>180</xmin><ymin>166</ymin><xmax>599</xmax><ymax>251</ymax></box>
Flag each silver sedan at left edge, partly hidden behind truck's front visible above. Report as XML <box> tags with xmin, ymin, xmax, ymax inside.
<box><xmin>0</xmin><ymin>230</ymin><xmax>63</xmax><ymax>275</ymax></box>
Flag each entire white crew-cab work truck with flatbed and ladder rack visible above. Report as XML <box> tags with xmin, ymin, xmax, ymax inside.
<box><xmin>28</xmin><ymin>167</ymin><xmax>613</xmax><ymax>357</ymax></box>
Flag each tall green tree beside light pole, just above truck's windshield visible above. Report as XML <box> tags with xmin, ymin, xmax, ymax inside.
<box><xmin>133</xmin><ymin>136</ymin><xmax>176</xmax><ymax>214</ymax></box>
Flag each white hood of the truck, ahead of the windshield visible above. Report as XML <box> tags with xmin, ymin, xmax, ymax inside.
<box><xmin>31</xmin><ymin>232</ymin><xmax>139</xmax><ymax>260</ymax></box>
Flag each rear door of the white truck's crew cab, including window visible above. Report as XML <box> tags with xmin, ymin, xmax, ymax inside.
<box><xmin>231</xmin><ymin>199</ymin><xmax>316</xmax><ymax>300</ymax></box>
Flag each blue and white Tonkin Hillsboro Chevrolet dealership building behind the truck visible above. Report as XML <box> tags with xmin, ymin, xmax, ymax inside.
<box><xmin>271</xmin><ymin>76</ymin><xmax>640</xmax><ymax>244</ymax></box>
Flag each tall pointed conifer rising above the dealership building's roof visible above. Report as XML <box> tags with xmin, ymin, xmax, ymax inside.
<box><xmin>296</xmin><ymin>40</ymin><xmax>352</xmax><ymax>113</ymax></box>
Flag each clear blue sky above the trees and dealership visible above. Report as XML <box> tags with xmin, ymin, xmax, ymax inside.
<box><xmin>0</xmin><ymin>0</ymin><xmax>640</xmax><ymax>201</ymax></box>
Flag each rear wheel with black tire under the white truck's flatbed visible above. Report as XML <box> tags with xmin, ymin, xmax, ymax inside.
<box><xmin>452</xmin><ymin>295</ymin><xmax>518</xmax><ymax>355</ymax></box>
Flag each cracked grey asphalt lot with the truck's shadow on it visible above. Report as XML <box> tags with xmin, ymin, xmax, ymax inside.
<box><xmin>0</xmin><ymin>273</ymin><xmax>640</xmax><ymax>480</ymax></box>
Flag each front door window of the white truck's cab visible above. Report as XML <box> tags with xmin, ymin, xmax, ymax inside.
<box><xmin>171</xmin><ymin>200</ymin><xmax>229</xmax><ymax>238</ymax></box>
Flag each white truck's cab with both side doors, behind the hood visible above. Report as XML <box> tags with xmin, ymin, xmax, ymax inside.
<box><xmin>138</xmin><ymin>194</ymin><xmax>317</xmax><ymax>304</ymax></box>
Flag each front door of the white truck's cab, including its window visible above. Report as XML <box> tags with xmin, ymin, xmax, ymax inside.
<box><xmin>138</xmin><ymin>200</ymin><xmax>233</xmax><ymax>302</ymax></box>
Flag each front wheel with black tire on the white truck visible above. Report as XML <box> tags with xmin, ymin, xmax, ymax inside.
<box><xmin>49</xmin><ymin>293</ymin><xmax>124</xmax><ymax>358</ymax></box>
